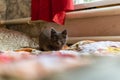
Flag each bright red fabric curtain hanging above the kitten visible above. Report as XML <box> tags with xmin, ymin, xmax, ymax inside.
<box><xmin>31</xmin><ymin>0</ymin><xmax>74</xmax><ymax>24</ymax></box>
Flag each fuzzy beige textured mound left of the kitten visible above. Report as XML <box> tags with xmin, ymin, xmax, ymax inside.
<box><xmin>0</xmin><ymin>28</ymin><xmax>38</xmax><ymax>50</ymax></box>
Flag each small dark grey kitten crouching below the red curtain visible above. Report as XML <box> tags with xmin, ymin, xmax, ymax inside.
<box><xmin>39</xmin><ymin>28</ymin><xmax>67</xmax><ymax>51</ymax></box>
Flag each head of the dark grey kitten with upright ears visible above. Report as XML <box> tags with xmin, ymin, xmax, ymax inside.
<box><xmin>51</xmin><ymin>28</ymin><xmax>67</xmax><ymax>50</ymax></box>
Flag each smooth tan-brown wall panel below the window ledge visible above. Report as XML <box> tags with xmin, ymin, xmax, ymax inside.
<box><xmin>65</xmin><ymin>15</ymin><xmax>120</xmax><ymax>36</ymax></box>
